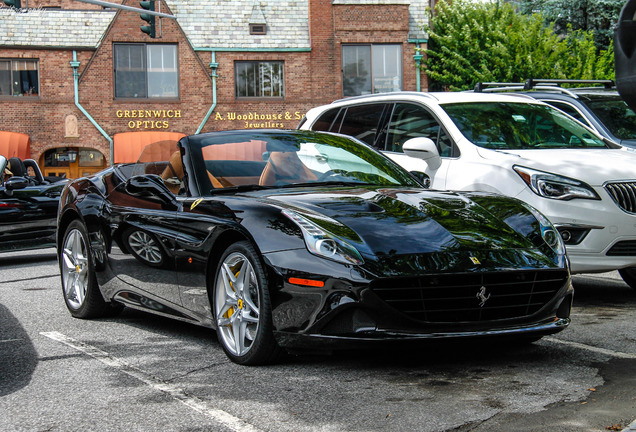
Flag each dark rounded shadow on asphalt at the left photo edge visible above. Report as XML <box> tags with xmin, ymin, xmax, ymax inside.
<box><xmin>0</xmin><ymin>304</ymin><xmax>38</xmax><ymax>397</ymax></box>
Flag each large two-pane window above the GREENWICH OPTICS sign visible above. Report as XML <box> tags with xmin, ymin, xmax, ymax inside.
<box><xmin>113</xmin><ymin>43</ymin><xmax>179</xmax><ymax>99</ymax></box>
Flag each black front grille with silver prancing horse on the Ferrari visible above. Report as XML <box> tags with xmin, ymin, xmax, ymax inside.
<box><xmin>371</xmin><ymin>270</ymin><xmax>569</xmax><ymax>323</ymax></box>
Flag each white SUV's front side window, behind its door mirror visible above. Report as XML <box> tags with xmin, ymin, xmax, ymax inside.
<box><xmin>385</xmin><ymin>103</ymin><xmax>453</xmax><ymax>156</ymax></box>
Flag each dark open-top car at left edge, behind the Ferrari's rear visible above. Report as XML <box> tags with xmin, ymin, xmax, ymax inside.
<box><xmin>0</xmin><ymin>156</ymin><xmax>66</xmax><ymax>252</ymax></box>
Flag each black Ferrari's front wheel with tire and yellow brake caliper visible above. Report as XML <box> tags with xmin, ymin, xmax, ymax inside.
<box><xmin>213</xmin><ymin>241</ymin><xmax>281</xmax><ymax>365</ymax></box>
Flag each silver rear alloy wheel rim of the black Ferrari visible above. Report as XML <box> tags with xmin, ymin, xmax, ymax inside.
<box><xmin>62</xmin><ymin>229</ymin><xmax>89</xmax><ymax>309</ymax></box>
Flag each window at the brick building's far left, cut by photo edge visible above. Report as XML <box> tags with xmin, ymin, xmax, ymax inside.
<box><xmin>0</xmin><ymin>59</ymin><xmax>40</xmax><ymax>96</ymax></box>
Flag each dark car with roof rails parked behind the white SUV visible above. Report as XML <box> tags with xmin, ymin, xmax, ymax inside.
<box><xmin>475</xmin><ymin>79</ymin><xmax>636</xmax><ymax>148</ymax></box>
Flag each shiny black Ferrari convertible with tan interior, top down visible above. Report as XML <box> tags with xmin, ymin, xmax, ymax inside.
<box><xmin>57</xmin><ymin>130</ymin><xmax>573</xmax><ymax>364</ymax></box>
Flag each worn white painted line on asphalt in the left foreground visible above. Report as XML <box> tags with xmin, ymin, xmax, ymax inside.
<box><xmin>40</xmin><ymin>332</ymin><xmax>260</xmax><ymax>432</ymax></box>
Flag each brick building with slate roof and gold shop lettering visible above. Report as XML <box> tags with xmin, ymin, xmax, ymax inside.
<box><xmin>0</xmin><ymin>0</ymin><xmax>429</xmax><ymax>177</ymax></box>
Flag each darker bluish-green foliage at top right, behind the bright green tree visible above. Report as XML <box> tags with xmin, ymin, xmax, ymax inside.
<box><xmin>518</xmin><ymin>0</ymin><xmax>625</xmax><ymax>49</ymax></box>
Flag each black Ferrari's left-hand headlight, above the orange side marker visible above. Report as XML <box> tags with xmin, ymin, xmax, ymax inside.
<box><xmin>282</xmin><ymin>210</ymin><xmax>364</xmax><ymax>264</ymax></box>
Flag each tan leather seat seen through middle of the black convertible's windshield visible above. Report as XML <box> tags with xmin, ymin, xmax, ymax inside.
<box><xmin>258</xmin><ymin>151</ymin><xmax>317</xmax><ymax>186</ymax></box>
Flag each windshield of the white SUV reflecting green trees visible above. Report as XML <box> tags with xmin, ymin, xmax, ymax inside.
<box><xmin>442</xmin><ymin>102</ymin><xmax>606</xmax><ymax>150</ymax></box>
